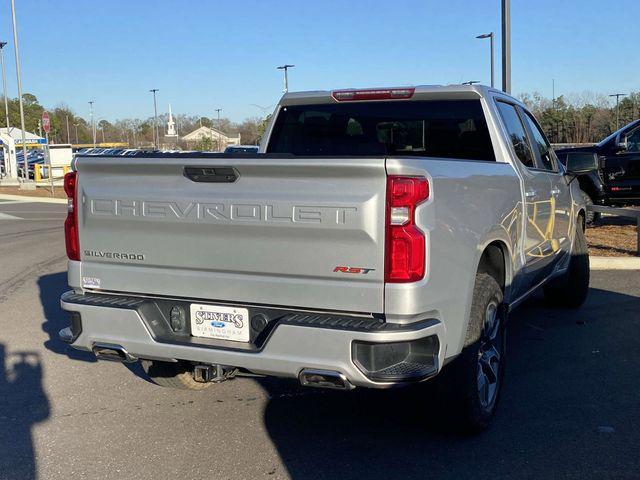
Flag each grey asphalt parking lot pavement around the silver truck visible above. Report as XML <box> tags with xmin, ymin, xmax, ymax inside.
<box><xmin>0</xmin><ymin>202</ymin><xmax>640</xmax><ymax>480</ymax></box>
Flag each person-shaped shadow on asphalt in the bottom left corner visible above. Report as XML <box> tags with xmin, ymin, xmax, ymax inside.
<box><xmin>0</xmin><ymin>344</ymin><xmax>49</xmax><ymax>480</ymax></box>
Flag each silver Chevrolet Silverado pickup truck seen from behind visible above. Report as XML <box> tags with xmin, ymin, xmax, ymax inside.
<box><xmin>60</xmin><ymin>85</ymin><xmax>596</xmax><ymax>430</ymax></box>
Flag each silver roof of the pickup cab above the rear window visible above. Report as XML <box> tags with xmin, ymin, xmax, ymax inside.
<box><xmin>280</xmin><ymin>84</ymin><xmax>519</xmax><ymax>105</ymax></box>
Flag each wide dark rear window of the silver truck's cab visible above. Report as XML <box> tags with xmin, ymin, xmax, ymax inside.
<box><xmin>267</xmin><ymin>100</ymin><xmax>495</xmax><ymax>161</ymax></box>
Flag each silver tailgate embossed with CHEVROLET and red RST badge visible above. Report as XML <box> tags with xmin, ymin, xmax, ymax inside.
<box><xmin>73</xmin><ymin>155</ymin><xmax>386</xmax><ymax>312</ymax></box>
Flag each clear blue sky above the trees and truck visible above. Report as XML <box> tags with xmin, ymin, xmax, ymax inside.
<box><xmin>0</xmin><ymin>0</ymin><xmax>640</xmax><ymax>121</ymax></box>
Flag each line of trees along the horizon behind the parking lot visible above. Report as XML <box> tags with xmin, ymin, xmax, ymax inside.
<box><xmin>0</xmin><ymin>92</ymin><xmax>640</xmax><ymax>150</ymax></box>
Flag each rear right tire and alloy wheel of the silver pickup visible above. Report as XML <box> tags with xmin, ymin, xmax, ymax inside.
<box><xmin>442</xmin><ymin>273</ymin><xmax>506</xmax><ymax>433</ymax></box>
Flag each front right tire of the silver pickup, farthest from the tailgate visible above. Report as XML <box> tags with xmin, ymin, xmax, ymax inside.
<box><xmin>544</xmin><ymin>218</ymin><xmax>589</xmax><ymax>308</ymax></box>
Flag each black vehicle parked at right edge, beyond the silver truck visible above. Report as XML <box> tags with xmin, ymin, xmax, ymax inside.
<box><xmin>556</xmin><ymin>119</ymin><xmax>640</xmax><ymax>215</ymax></box>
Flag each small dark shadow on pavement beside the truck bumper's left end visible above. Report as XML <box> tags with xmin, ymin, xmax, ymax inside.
<box><xmin>38</xmin><ymin>272</ymin><xmax>97</xmax><ymax>362</ymax></box>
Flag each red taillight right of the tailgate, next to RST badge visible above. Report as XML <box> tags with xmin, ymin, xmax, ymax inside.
<box><xmin>385</xmin><ymin>175</ymin><xmax>429</xmax><ymax>283</ymax></box>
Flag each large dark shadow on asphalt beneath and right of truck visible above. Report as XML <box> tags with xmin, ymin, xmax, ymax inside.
<box><xmin>259</xmin><ymin>289</ymin><xmax>640</xmax><ymax>479</ymax></box>
